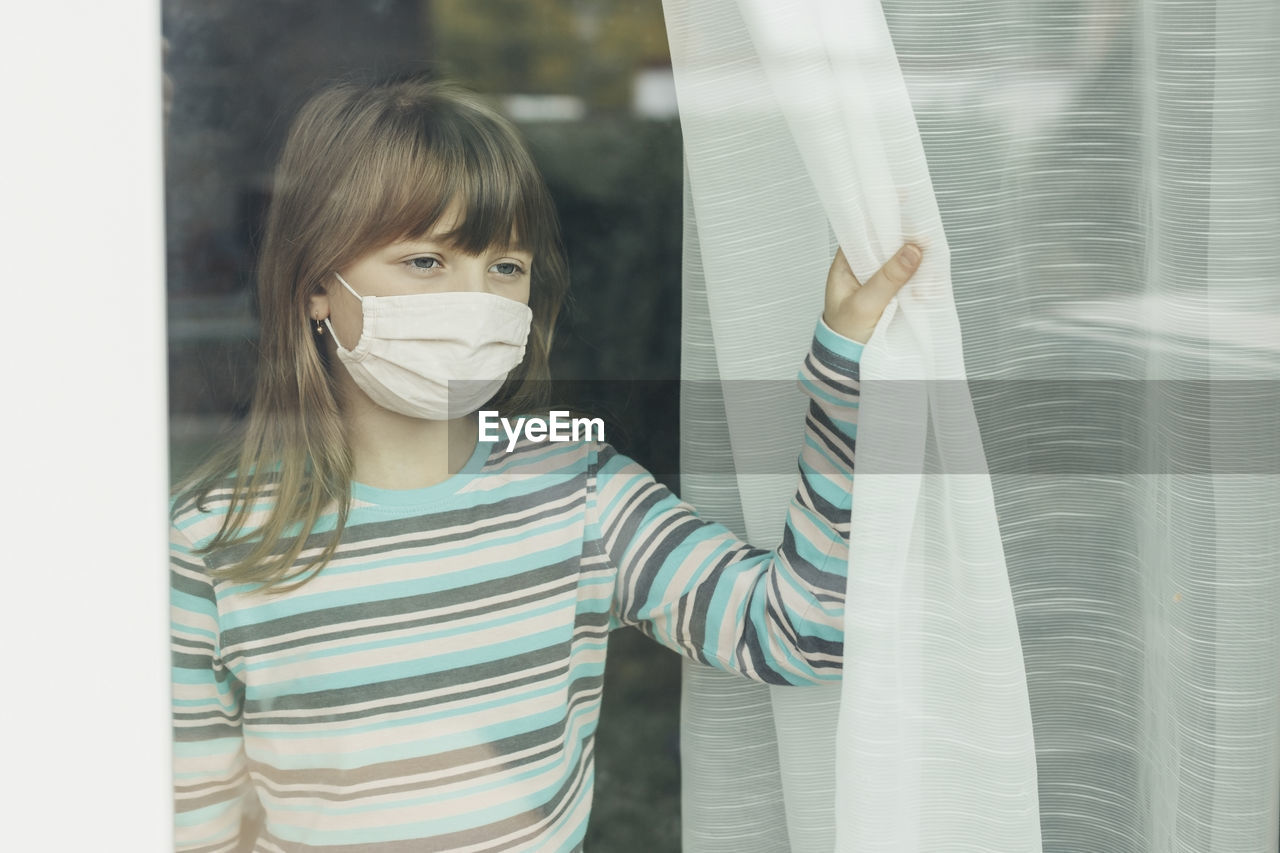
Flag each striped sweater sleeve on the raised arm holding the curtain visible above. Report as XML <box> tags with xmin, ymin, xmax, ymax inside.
<box><xmin>588</xmin><ymin>321</ymin><xmax>863</xmax><ymax>684</ymax></box>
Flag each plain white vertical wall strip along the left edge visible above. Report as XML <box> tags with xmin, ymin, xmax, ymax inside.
<box><xmin>0</xmin><ymin>0</ymin><xmax>172</xmax><ymax>852</ymax></box>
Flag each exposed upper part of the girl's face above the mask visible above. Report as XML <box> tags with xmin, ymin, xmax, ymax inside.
<box><xmin>308</xmin><ymin>202</ymin><xmax>534</xmax><ymax>350</ymax></box>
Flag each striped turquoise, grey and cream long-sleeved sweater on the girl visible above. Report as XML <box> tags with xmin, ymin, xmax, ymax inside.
<box><xmin>170</xmin><ymin>315</ymin><xmax>861</xmax><ymax>853</ymax></box>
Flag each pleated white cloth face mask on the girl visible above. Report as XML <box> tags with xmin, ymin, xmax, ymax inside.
<box><xmin>325</xmin><ymin>273</ymin><xmax>534</xmax><ymax>420</ymax></box>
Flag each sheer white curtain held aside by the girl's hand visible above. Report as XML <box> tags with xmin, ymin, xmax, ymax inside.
<box><xmin>664</xmin><ymin>0</ymin><xmax>1280</xmax><ymax>853</ymax></box>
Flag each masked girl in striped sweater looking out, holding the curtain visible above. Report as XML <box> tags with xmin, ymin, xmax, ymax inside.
<box><xmin>172</xmin><ymin>79</ymin><xmax>919</xmax><ymax>852</ymax></box>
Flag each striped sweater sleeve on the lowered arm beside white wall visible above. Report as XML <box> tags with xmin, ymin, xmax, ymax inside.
<box><xmin>169</xmin><ymin>528</ymin><xmax>248</xmax><ymax>853</ymax></box>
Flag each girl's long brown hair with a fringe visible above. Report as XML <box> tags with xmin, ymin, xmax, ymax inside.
<box><xmin>174</xmin><ymin>77</ymin><xmax>568</xmax><ymax>592</ymax></box>
